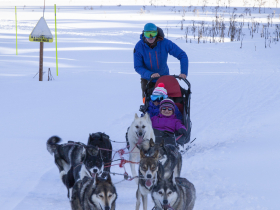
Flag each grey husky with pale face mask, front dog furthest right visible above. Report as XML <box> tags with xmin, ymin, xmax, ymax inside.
<box><xmin>152</xmin><ymin>173</ymin><xmax>196</xmax><ymax>210</ymax></box>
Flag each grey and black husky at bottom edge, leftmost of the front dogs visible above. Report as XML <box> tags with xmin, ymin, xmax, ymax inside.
<box><xmin>71</xmin><ymin>175</ymin><xmax>118</xmax><ymax>210</ymax></box>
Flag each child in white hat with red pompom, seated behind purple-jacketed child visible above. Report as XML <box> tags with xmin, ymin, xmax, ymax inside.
<box><xmin>147</xmin><ymin>83</ymin><xmax>183</xmax><ymax>121</ymax></box>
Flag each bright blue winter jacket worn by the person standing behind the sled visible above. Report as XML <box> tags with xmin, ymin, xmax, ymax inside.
<box><xmin>134</xmin><ymin>27</ymin><xmax>189</xmax><ymax>80</ymax></box>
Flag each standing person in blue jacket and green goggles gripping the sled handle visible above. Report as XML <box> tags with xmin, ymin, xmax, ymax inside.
<box><xmin>134</xmin><ymin>23</ymin><xmax>189</xmax><ymax>102</ymax></box>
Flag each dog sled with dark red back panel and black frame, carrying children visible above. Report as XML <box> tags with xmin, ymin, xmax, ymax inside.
<box><xmin>139</xmin><ymin>75</ymin><xmax>192</xmax><ymax>145</ymax></box>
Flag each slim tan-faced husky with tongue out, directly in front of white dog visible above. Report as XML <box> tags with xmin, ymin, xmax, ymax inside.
<box><xmin>136</xmin><ymin>149</ymin><xmax>163</xmax><ymax>210</ymax></box>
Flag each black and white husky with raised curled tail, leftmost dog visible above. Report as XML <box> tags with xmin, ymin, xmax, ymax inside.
<box><xmin>47</xmin><ymin>136</ymin><xmax>102</xmax><ymax>198</ymax></box>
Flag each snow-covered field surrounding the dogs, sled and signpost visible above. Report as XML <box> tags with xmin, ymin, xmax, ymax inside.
<box><xmin>0</xmin><ymin>0</ymin><xmax>280</xmax><ymax>210</ymax></box>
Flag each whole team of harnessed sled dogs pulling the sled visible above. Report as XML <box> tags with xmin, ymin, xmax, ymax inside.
<box><xmin>47</xmin><ymin>113</ymin><xmax>196</xmax><ymax>210</ymax></box>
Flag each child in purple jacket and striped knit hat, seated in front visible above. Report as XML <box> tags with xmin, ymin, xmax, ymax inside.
<box><xmin>151</xmin><ymin>99</ymin><xmax>187</xmax><ymax>136</ymax></box>
